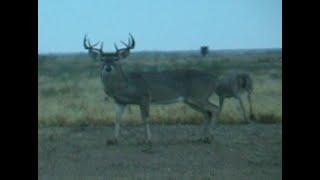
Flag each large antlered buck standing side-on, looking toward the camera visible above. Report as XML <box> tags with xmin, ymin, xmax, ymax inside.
<box><xmin>83</xmin><ymin>34</ymin><xmax>219</xmax><ymax>143</ymax></box>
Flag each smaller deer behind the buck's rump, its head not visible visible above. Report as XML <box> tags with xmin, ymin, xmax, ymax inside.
<box><xmin>215</xmin><ymin>72</ymin><xmax>254</xmax><ymax>122</ymax></box>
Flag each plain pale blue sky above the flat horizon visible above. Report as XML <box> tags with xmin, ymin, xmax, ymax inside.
<box><xmin>38</xmin><ymin>0</ymin><xmax>282</xmax><ymax>53</ymax></box>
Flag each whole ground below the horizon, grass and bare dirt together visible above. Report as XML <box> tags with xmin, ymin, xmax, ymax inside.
<box><xmin>38</xmin><ymin>50</ymin><xmax>282</xmax><ymax>180</ymax></box>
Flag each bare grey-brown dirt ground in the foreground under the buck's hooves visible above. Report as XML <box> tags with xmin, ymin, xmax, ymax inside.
<box><xmin>38</xmin><ymin>123</ymin><xmax>282</xmax><ymax>180</ymax></box>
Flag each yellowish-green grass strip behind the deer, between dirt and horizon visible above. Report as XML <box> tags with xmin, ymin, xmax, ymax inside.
<box><xmin>38</xmin><ymin>49</ymin><xmax>282</xmax><ymax>127</ymax></box>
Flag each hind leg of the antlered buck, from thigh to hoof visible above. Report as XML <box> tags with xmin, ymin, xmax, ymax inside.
<box><xmin>186</xmin><ymin>100</ymin><xmax>219</xmax><ymax>143</ymax></box>
